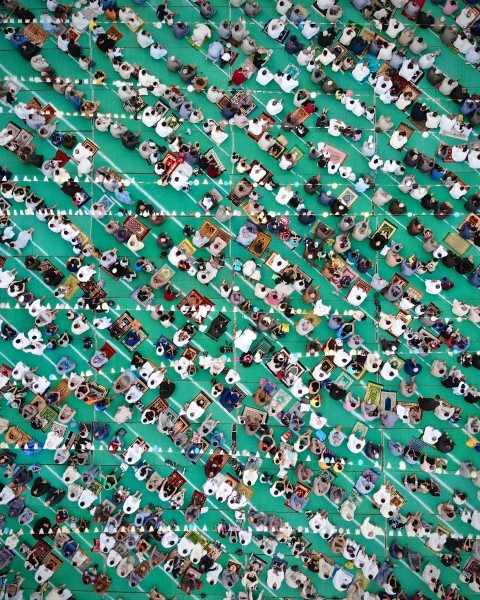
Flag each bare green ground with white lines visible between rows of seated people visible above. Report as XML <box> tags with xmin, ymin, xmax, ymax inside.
<box><xmin>0</xmin><ymin>0</ymin><xmax>480</xmax><ymax>600</ymax></box>
